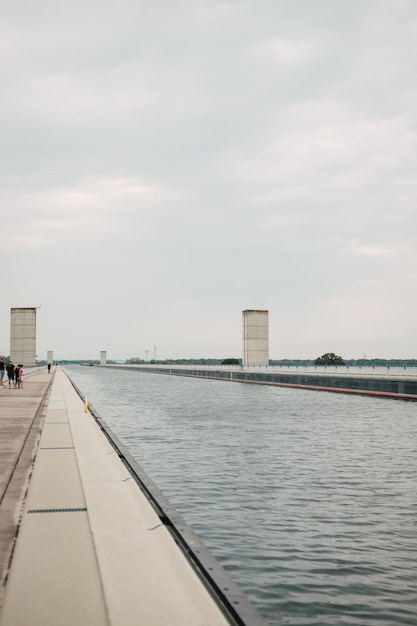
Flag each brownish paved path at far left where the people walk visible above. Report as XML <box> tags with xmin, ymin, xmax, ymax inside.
<box><xmin>0</xmin><ymin>368</ymin><xmax>52</xmax><ymax>607</ymax></box>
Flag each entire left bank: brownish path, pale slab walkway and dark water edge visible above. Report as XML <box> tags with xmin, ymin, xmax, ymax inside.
<box><xmin>0</xmin><ymin>368</ymin><xmax>266</xmax><ymax>626</ymax></box>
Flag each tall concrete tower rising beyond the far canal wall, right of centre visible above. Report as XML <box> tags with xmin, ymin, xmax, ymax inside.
<box><xmin>242</xmin><ymin>309</ymin><xmax>269</xmax><ymax>365</ymax></box>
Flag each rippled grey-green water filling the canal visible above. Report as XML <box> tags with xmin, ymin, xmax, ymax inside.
<box><xmin>66</xmin><ymin>366</ymin><xmax>417</xmax><ymax>626</ymax></box>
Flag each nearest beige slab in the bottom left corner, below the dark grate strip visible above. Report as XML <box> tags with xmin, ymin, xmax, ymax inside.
<box><xmin>0</xmin><ymin>512</ymin><xmax>109</xmax><ymax>626</ymax></box>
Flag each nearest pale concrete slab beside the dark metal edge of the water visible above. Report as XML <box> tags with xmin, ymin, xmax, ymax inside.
<box><xmin>94</xmin><ymin>525</ymin><xmax>227</xmax><ymax>626</ymax></box>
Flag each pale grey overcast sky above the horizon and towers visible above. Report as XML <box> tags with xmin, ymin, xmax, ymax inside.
<box><xmin>0</xmin><ymin>0</ymin><xmax>417</xmax><ymax>359</ymax></box>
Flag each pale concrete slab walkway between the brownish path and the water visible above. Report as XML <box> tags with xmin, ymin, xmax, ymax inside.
<box><xmin>0</xmin><ymin>369</ymin><xmax>227</xmax><ymax>626</ymax></box>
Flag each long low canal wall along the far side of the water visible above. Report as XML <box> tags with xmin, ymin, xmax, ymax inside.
<box><xmin>101</xmin><ymin>365</ymin><xmax>417</xmax><ymax>401</ymax></box>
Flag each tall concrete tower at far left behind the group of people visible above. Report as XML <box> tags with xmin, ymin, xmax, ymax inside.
<box><xmin>10</xmin><ymin>307</ymin><xmax>36</xmax><ymax>365</ymax></box>
